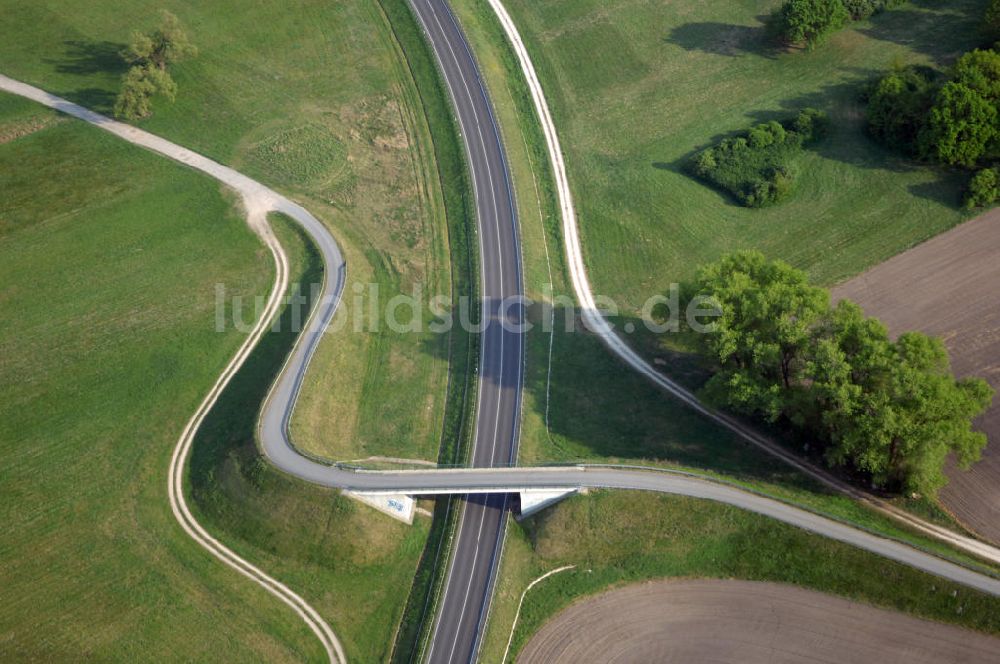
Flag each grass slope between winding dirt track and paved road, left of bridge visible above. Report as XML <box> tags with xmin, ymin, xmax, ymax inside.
<box><xmin>189</xmin><ymin>217</ymin><xmax>430</xmax><ymax>661</ymax></box>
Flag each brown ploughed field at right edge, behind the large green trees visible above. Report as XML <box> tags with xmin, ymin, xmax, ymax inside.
<box><xmin>833</xmin><ymin>209</ymin><xmax>1000</xmax><ymax>544</ymax></box>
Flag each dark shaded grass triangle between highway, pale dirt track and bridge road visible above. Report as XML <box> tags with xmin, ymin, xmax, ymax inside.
<box><xmin>488</xmin><ymin>305</ymin><xmax>813</xmax><ymax>488</ymax></box>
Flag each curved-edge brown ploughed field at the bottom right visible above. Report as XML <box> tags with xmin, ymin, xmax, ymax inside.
<box><xmin>517</xmin><ymin>580</ymin><xmax>1000</xmax><ymax>664</ymax></box>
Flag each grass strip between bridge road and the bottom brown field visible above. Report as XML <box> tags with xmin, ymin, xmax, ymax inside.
<box><xmin>483</xmin><ymin>492</ymin><xmax>1000</xmax><ymax>662</ymax></box>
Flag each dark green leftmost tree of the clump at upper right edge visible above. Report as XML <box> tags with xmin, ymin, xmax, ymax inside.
<box><xmin>866</xmin><ymin>68</ymin><xmax>934</xmax><ymax>154</ymax></box>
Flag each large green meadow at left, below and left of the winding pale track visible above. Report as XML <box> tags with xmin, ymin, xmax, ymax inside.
<box><xmin>0</xmin><ymin>95</ymin><xmax>322</xmax><ymax>661</ymax></box>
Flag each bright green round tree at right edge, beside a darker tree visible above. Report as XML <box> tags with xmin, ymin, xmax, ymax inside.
<box><xmin>920</xmin><ymin>81</ymin><xmax>1000</xmax><ymax>168</ymax></box>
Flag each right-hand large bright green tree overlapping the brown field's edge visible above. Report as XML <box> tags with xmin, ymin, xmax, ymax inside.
<box><xmin>807</xmin><ymin>302</ymin><xmax>992</xmax><ymax>495</ymax></box>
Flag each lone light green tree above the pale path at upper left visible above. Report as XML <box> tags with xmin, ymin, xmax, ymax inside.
<box><xmin>114</xmin><ymin>10</ymin><xmax>198</xmax><ymax>121</ymax></box>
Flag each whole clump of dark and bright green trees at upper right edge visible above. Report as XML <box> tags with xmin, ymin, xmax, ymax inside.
<box><xmin>867</xmin><ymin>49</ymin><xmax>1000</xmax><ymax>205</ymax></box>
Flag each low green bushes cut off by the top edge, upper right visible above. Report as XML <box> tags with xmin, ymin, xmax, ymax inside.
<box><xmin>774</xmin><ymin>0</ymin><xmax>905</xmax><ymax>48</ymax></box>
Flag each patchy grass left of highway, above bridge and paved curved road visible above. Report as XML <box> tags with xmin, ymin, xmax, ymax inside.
<box><xmin>0</xmin><ymin>0</ymin><xmax>449</xmax><ymax>459</ymax></box>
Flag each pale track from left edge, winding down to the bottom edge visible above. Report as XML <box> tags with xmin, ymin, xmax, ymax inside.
<box><xmin>0</xmin><ymin>74</ymin><xmax>347</xmax><ymax>664</ymax></box>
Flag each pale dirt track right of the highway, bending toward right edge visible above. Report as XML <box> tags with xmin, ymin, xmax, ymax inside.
<box><xmin>488</xmin><ymin>0</ymin><xmax>1000</xmax><ymax>563</ymax></box>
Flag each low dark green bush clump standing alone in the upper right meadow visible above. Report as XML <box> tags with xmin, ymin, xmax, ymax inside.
<box><xmin>691</xmin><ymin>108</ymin><xmax>827</xmax><ymax>208</ymax></box>
